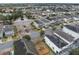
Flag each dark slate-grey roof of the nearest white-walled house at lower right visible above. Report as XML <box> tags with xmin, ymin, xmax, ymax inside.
<box><xmin>46</xmin><ymin>34</ymin><xmax>67</xmax><ymax>48</ymax></box>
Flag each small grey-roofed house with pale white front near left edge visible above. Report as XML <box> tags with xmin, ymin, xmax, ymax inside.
<box><xmin>3</xmin><ymin>25</ymin><xmax>14</xmax><ymax>36</ymax></box>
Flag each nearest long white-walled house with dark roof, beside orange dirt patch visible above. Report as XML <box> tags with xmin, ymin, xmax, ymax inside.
<box><xmin>44</xmin><ymin>33</ymin><xmax>68</xmax><ymax>53</ymax></box>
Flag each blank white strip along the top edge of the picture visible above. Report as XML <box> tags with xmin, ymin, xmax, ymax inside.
<box><xmin>0</xmin><ymin>0</ymin><xmax>79</xmax><ymax>3</ymax></box>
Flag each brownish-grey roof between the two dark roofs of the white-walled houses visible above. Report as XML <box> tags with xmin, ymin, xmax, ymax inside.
<box><xmin>55</xmin><ymin>30</ymin><xmax>74</xmax><ymax>42</ymax></box>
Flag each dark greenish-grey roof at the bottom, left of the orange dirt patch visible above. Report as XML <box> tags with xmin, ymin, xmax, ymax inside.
<box><xmin>14</xmin><ymin>40</ymin><xmax>27</xmax><ymax>55</ymax></box>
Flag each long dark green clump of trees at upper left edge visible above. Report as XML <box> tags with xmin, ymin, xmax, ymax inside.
<box><xmin>0</xmin><ymin>10</ymin><xmax>23</xmax><ymax>24</ymax></box>
